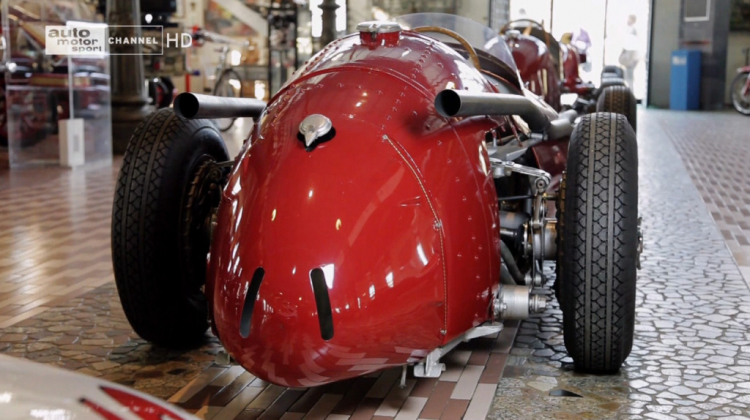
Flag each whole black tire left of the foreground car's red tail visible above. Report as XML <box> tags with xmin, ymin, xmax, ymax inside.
<box><xmin>112</xmin><ymin>108</ymin><xmax>229</xmax><ymax>348</ymax></box>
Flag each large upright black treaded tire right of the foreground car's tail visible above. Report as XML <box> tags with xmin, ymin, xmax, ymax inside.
<box><xmin>558</xmin><ymin>113</ymin><xmax>638</xmax><ymax>374</ymax></box>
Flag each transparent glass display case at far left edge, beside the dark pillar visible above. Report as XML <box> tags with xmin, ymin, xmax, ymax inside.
<box><xmin>0</xmin><ymin>0</ymin><xmax>112</xmax><ymax>168</ymax></box>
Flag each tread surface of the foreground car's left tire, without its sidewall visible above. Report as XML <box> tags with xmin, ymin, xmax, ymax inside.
<box><xmin>112</xmin><ymin>108</ymin><xmax>223</xmax><ymax>347</ymax></box>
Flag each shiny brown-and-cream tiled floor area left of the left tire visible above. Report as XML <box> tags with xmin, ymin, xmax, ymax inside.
<box><xmin>0</xmin><ymin>165</ymin><xmax>116</xmax><ymax>329</ymax></box>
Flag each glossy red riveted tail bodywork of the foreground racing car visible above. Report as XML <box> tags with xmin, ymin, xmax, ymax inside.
<box><xmin>206</xmin><ymin>32</ymin><xmax>500</xmax><ymax>386</ymax></box>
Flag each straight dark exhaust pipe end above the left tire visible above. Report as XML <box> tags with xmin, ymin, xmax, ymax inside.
<box><xmin>174</xmin><ymin>92</ymin><xmax>266</xmax><ymax>119</ymax></box>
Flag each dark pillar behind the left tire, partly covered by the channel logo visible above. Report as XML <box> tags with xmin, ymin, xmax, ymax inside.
<box><xmin>107</xmin><ymin>0</ymin><xmax>153</xmax><ymax>154</ymax></box>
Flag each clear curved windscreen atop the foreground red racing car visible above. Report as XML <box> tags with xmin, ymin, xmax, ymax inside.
<box><xmin>396</xmin><ymin>13</ymin><xmax>518</xmax><ymax>73</ymax></box>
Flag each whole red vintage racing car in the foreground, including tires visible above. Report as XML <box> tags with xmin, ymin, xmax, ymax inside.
<box><xmin>112</xmin><ymin>14</ymin><xmax>641</xmax><ymax>387</ymax></box>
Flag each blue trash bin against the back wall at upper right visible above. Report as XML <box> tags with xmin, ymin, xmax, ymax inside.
<box><xmin>669</xmin><ymin>50</ymin><xmax>701</xmax><ymax>111</ymax></box>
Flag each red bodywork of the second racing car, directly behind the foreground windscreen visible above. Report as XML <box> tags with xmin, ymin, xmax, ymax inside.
<box><xmin>508</xmin><ymin>35</ymin><xmax>562</xmax><ymax>111</ymax></box>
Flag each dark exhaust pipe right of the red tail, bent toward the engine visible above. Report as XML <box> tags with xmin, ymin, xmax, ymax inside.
<box><xmin>435</xmin><ymin>89</ymin><xmax>550</xmax><ymax>132</ymax></box>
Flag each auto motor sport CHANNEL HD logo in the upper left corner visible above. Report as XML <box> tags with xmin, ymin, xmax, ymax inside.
<box><xmin>45</xmin><ymin>24</ymin><xmax>193</xmax><ymax>55</ymax></box>
